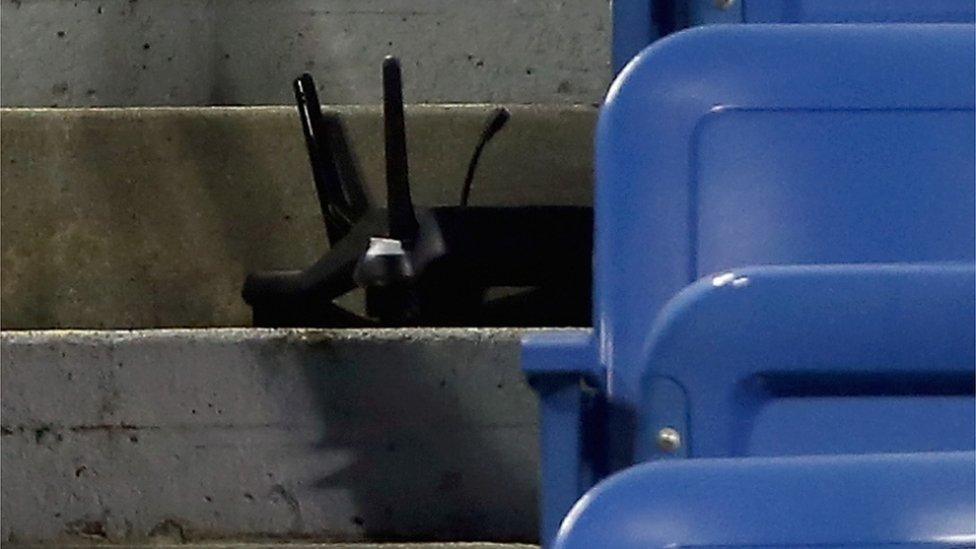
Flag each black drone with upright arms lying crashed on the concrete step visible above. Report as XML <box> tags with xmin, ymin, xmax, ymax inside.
<box><xmin>243</xmin><ymin>57</ymin><xmax>593</xmax><ymax>327</ymax></box>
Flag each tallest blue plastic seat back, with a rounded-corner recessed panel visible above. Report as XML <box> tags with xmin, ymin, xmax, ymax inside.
<box><xmin>594</xmin><ymin>25</ymin><xmax>976</xmax><ymax>407</ymax></box>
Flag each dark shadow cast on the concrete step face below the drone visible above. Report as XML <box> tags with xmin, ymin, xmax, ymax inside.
<box><xmin>304</xmin><ymin>335</ymin><xmax>538</xmax><ymax>542</ymax></box>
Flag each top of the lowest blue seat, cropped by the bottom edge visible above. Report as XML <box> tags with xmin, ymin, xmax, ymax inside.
<box><xmin>554</xmin><ymin>452</ymin><xmax>976</xmax><ymax>549</ymax></box>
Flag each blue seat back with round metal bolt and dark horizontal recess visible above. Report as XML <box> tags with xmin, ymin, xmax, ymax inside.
<box><xmin>634</xmin><ymin>264</ymin><xmax>976</xmax><ymax>461</ymax></box>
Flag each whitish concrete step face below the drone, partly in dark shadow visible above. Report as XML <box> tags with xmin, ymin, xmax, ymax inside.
<box><xmin>0</xmin><ymin>329</ymin><xmax>538</xmax><ymax>543</ymax></box>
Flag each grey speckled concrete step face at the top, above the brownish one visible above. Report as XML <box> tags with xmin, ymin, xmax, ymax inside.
<box><xmin>0</xmin><ymin>0</ymin><xmax>610</xmax><ymax>107</ymax></box>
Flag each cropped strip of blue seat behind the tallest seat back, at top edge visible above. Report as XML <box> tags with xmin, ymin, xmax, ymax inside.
<box><xmin>613</xmin><ymin>0</ymin><xmax>976</xmax><ymax>73</ymax></box>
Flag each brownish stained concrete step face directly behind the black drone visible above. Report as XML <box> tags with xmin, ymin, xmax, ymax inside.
<box><xmin>0</xmin><ymin>106</ymin><xmax>596</xmax><ymax>329</ymax></box>
